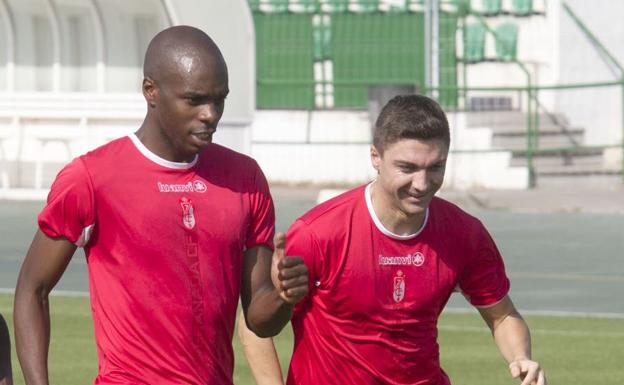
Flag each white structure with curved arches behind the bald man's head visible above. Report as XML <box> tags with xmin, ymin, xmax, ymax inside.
<box><xmin>0</xmin><ymin>0</ymin><xmax>255</xmax><ymax>197</ymax></box>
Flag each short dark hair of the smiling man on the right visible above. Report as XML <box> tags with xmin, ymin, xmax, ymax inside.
<box><xmin>373</xmin><ymin>95</ymin><xmax>451</xmax><ymax>154</ymax></box>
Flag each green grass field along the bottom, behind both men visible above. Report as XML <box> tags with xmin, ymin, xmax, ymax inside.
<box><xmin>0</xmin><ymin>295</ymin><xmax>624</xmax><ymax>385</ymax></box>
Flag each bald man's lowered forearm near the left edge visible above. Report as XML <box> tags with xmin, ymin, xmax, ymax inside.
<box><xmin>14</xmin><ymin>287</ymin><xmax>50</xmax><ymax>385</ymax></box>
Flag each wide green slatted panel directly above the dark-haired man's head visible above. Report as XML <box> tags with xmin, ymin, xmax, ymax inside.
<box><xmin>331</xmin><ymin>13</ymin><xmax>424</xmax><ymax>108</ymax></box>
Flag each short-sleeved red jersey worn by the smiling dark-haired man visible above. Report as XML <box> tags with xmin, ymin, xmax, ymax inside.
<box><xmin>286</xmin><ymin>184</ymin><xmax>509</xmax><ymax>385</ymax></box>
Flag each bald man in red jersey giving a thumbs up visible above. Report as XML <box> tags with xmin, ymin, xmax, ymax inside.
<box><xmin>15</xmin><ymin>26</ymin><xmax>308</xmax><ymax>385</ymax></box>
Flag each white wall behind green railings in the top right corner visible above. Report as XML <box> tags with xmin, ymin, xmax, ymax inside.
<box><xmin>557</xmin><ymin>0</ymin><xmax>624</xmax><ymax>145</ymax></box>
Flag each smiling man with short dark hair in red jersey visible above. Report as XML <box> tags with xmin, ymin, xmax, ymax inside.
<box><xmin>239</xmin><ymin>95</ymin><xmax>546</xmax><ymax>385</ymax></box>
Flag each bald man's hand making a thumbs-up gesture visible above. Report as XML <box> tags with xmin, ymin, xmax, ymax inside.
<box><xmin>271</xmin><ymin>233</ymin><xmax>308</xmax><ymax>305</ymax></box>
